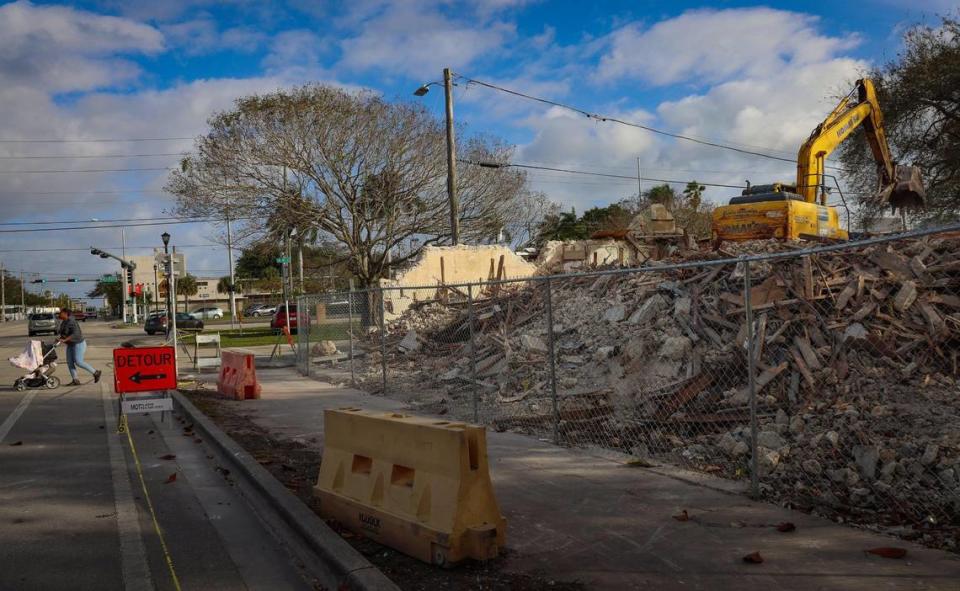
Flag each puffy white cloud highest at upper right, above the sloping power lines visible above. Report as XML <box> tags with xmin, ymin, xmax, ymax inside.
<box><xmin>597</xmin><ymin>8</ymin><xmax>858</xmax><ymax>86</ymax></box>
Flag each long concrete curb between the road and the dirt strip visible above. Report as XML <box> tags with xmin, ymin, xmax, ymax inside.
<box><xmin>173</xmin><ymin>391</ymin><xmax>399</xmax><ymax>591</ymax></box>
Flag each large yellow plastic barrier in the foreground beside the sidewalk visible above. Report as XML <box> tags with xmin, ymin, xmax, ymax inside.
<box><xmin>314</xmin><ymin>408</ymin><xmax>507</xmax><ymax>566</ymax></box>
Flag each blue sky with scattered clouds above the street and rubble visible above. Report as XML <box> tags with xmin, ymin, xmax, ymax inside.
<box><xmin>0</xmin><ymin>0</ymin><xmax>958</xmax><ymax>303</ymax></box>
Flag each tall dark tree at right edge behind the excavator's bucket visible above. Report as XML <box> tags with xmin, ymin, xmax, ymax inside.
<box><xmin>839</xmin><ymin>16</ymin><xmax>960</xmax><ymax>227</ymax></box>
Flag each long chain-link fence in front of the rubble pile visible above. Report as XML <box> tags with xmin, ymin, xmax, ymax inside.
<box><xmin>299</xmin><ymin>228</ymin><xmax>960</xmax><ymax>549</ymax></box>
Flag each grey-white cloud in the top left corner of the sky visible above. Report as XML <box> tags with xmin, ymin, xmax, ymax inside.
<box><xmin>0</xmin><ymin>1</ymin><xmax>164</xmax><ymax>92</ymax></box>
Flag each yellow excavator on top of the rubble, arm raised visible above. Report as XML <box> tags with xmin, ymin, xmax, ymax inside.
<box><xmin>713</xmin><ymin>78</ymin><xmax>926</xmax><ymax>244</ymax></box>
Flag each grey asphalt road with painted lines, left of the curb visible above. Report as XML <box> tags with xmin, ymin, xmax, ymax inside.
<box><xmin>0</xmin><ymin>322</ymin><xmax>313</xmax><ymax>591</ymax></box>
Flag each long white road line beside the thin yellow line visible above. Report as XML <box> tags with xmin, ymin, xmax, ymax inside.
<box><xmin>100</xmin><ymin>383</ymin><xmax>154</xmax><ymax>591</ymax></box>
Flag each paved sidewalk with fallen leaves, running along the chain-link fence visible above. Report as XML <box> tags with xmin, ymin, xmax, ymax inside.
<box><xmin>199</xmin><ymin>369</ymin><xmax>960</xmax><ymax>591</ymax></box>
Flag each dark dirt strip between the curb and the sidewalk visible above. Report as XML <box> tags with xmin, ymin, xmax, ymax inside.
<box><xmin>182</xmin><ymin>391</ymin><xmax>585</xmax><ymax>591</ymax></box>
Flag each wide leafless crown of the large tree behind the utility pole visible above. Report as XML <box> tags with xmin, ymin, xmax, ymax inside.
<box><xmin>167</xmin><ymin>86</ymin><xmax>526</xmax><ymax>285</ymax></box>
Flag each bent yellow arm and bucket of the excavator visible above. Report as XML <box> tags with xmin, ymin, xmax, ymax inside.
<box><xmin>797</xmin><ymin>78</ymin><xmax>925</xmax><ymax>209</ymax></box>
